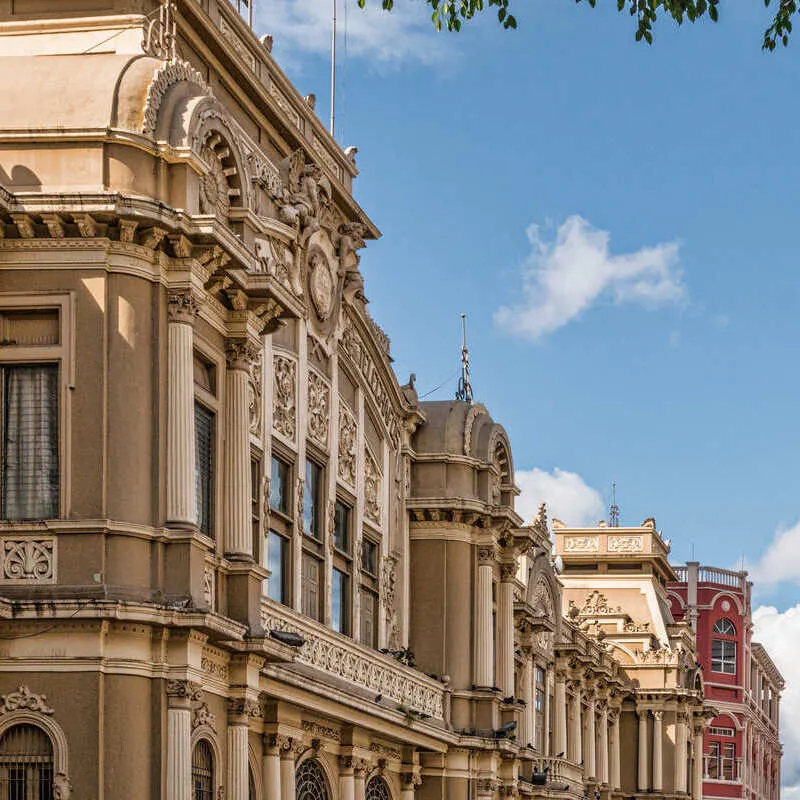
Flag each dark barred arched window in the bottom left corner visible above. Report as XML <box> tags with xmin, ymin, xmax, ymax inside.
<box><xmin>0</xmin><ymin>724</ymin><xmax>53</xmax><ymax>800</ymax></box>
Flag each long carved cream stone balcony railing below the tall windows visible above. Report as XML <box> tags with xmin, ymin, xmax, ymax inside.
<box><xmin>261</xmin><ymin>598</ymin><xmax>445</xmax><ymax>720</ymax></box>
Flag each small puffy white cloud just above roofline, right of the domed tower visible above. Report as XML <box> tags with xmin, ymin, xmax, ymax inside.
<box><xmin>514</xmin><ymin>467</ymin><xmax>604</xmax><ymax>528</ymax></box>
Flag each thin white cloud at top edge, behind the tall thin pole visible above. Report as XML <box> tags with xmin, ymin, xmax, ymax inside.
<box><xmin>257</xmin><ymin>0</ymin><xmax>452</xmax><ymax>65</ymax></box>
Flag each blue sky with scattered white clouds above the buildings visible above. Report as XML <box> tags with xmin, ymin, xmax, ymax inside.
<box><xmin>258</xmin><ymin>0</ymin><xmax>800</xmax><ymax>797</ymax></box>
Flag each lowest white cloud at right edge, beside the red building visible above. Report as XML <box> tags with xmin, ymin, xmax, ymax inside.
<box><xmin>753</xmin><ymin>605</ymin><xmax>800</xmax><ymax>800</ymax></box>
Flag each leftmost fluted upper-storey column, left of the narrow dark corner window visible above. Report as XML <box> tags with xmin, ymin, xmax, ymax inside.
<box><xmin>166</xmin><ymin>289</ymin><xmax>198</xmax><ymax>525</ymax></box>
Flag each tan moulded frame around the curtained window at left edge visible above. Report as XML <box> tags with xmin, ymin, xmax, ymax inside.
<box><xmin>0</xmin><ymin>292</ymin><xmax>75</xmax><ymax>525</ymax></box>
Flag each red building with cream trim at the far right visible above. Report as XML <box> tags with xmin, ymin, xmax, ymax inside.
<box><xmin>668</xmin><ymin>562</ymin><xmax>784</xmax><ymax>800</ymax></box>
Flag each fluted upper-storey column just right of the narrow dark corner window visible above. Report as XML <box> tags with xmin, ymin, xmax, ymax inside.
<box><xmin>223</xmin><ymin>339</ymin><xmax>258</xmax><ymax>558</ymax></box>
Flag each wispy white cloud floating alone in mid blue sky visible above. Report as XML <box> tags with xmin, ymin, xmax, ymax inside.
<box><xmin>494</xmin><ymin>214</ymin><xmax>686</xmax><ymax>339</ymax></box>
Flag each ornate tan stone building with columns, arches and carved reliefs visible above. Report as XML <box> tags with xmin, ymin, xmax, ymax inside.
<box><xmin>0</xmin><ymin>0</ymin><xmax>780</xmax><ymax>800</ymax></box>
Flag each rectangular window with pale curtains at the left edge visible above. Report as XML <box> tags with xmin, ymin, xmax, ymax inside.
<box><xmin>0</xmin><ymin>364</ymin><xmax>59</xmax><ymax>520</ymax></box>
